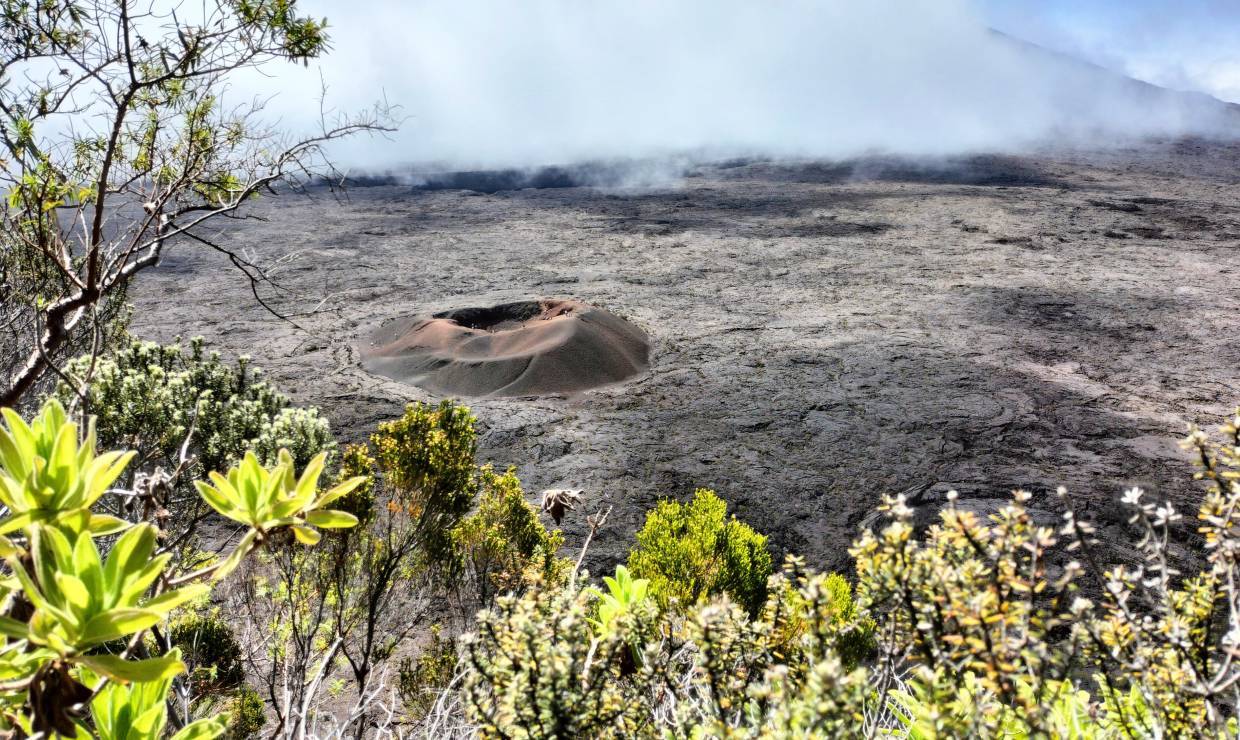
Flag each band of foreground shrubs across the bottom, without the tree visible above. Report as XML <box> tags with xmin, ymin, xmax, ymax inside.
<box><xmin>0</xmin><ymin>337</ymin><xmax>1240</xmax><ymax>739</ymax></box>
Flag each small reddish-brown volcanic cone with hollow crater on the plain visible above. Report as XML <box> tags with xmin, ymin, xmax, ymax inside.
<box><xmin>362</xmin><ymin>300</ymin><xmax>650</xmax><ymax>397</ymax></box>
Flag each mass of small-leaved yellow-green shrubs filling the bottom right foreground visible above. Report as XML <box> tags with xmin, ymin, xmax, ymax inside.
<box><xmin>465</xmin><ymin>406</ymin><xmax>1240</xmax><ymax>740</ymax></box>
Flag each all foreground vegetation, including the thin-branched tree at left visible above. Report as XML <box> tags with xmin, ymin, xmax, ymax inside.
<box><xmin>0</xmin><ymin>0</ymin><xmax>1240</xmax><ymax>740</ymax></box>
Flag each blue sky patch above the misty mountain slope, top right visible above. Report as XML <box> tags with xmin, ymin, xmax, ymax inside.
<box><xmin>978</xmin><ymin>0</ymin><xmax>1240</xmax><ymax>103</ymax></box>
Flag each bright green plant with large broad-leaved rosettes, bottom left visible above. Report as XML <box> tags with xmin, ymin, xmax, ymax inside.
<box><xmin>0</xmin><ymin>400</ymin><xmax>352</xmax><ymax>740</ymax></box>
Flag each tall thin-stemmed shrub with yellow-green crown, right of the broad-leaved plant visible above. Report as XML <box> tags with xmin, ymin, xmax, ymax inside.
<box><xmin>237</xmin><ymin>402</ymin><xmax>498</xmax><ymax>736</ymax></box>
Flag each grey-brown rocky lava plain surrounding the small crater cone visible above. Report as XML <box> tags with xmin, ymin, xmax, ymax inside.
<box><xmin>135</xmin><ymin>136</ymin><xmax>1240</xmax><ymax>568</ymax></box>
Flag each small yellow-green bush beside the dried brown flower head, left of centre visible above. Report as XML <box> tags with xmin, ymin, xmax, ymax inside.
<box><xmin>451</xmin><ymin>466</ymin><xmax>568</xmax><ymax>604</ymax></box>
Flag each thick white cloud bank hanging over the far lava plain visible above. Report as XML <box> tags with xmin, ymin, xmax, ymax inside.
<box><xmin>238</xmin><ymin>0</ymin><xmax>1240</xmax><ymax>170</ymax></box>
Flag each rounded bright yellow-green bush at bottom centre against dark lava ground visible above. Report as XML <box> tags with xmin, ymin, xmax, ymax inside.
<box><xmin>629</xmin><ymin>488</ymin><xmax>771</xmax><ymax>615</ymax></box>
